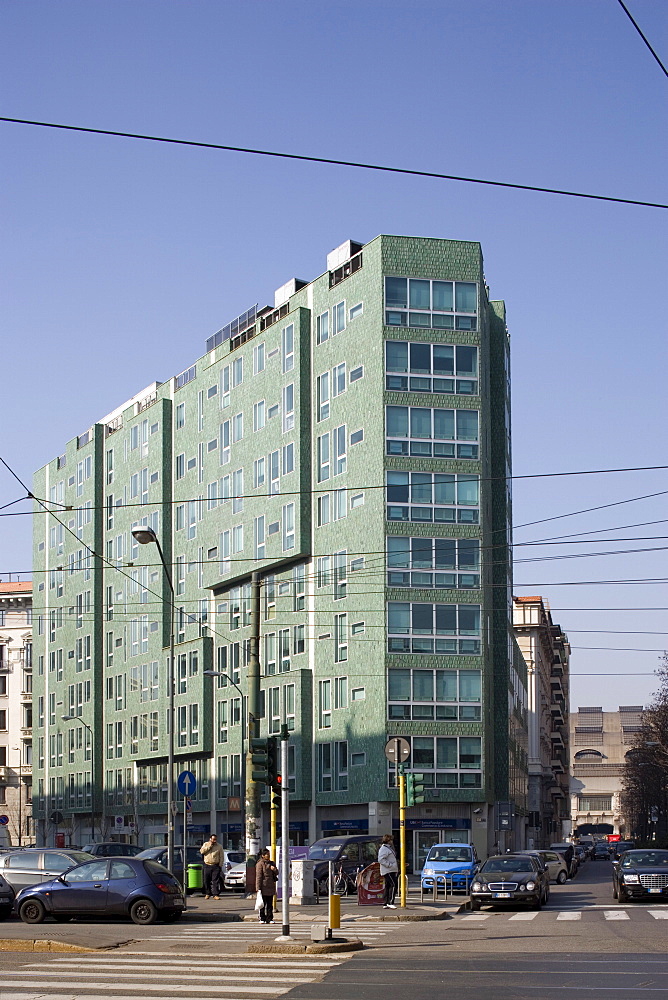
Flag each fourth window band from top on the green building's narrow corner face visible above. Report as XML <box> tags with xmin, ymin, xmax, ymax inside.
<box><xmin>386</xmin><ymin>472</ymin><xmax>480</xmax><ymax>524</ymax></box>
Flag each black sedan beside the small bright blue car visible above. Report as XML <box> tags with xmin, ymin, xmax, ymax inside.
<box><xmin>471</xmin><ymin>854</ymin><xmax>550</xmax><ymax>910</ymax></box>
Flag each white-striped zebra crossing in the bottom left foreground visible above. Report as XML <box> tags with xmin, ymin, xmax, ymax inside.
<box><xmin>0</xmin><ymin>954</ymin><xmax>345</xmax><ymax>1000</ymax></box>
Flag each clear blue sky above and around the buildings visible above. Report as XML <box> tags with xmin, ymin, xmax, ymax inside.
<box><xmin>0</xmin><ymin>0</ymin><xmax>668</xmax><ymax>709</ymax></box>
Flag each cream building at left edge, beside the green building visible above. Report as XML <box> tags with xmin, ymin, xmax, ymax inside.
<box><xmin>0</xmin><ymin>580</ymin><xmax>33</xmax><ymax>847</ymax></box>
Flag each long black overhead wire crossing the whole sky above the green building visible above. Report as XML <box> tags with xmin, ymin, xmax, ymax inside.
<box><xmin>0</xmin><ymin>116</ymin><xmax>668</xmax><ymax>209</ymax></box>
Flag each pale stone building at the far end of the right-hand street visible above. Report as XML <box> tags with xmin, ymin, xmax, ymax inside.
<box><xmin>571</xmin><ymin>705</ymin><xmax>643</xmax><ymax>837</ymax></box>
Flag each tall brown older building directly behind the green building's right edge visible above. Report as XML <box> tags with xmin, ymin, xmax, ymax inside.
<box><xmin>513</xmin><ymin>597</ymin><xmax>571</xmax><ymax>847</ymax></box>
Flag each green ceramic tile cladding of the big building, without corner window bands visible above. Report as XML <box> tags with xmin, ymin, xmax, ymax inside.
<box><xmin>34</xmin><ymin>236</ymin><xmax>526</xmax><ymax>842</ymax></box>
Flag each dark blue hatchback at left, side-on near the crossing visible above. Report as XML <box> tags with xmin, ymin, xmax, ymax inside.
<box><xmin>16</xmin><ymin>858</ymin><xmax>185</xmax><ymax>924</ymax></box>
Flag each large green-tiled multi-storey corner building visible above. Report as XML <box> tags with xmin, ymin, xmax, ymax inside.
<box><xmin>34</xmin><ymin>236</ymin><xmax>526</xmax><ymax>865</ymax></box>
